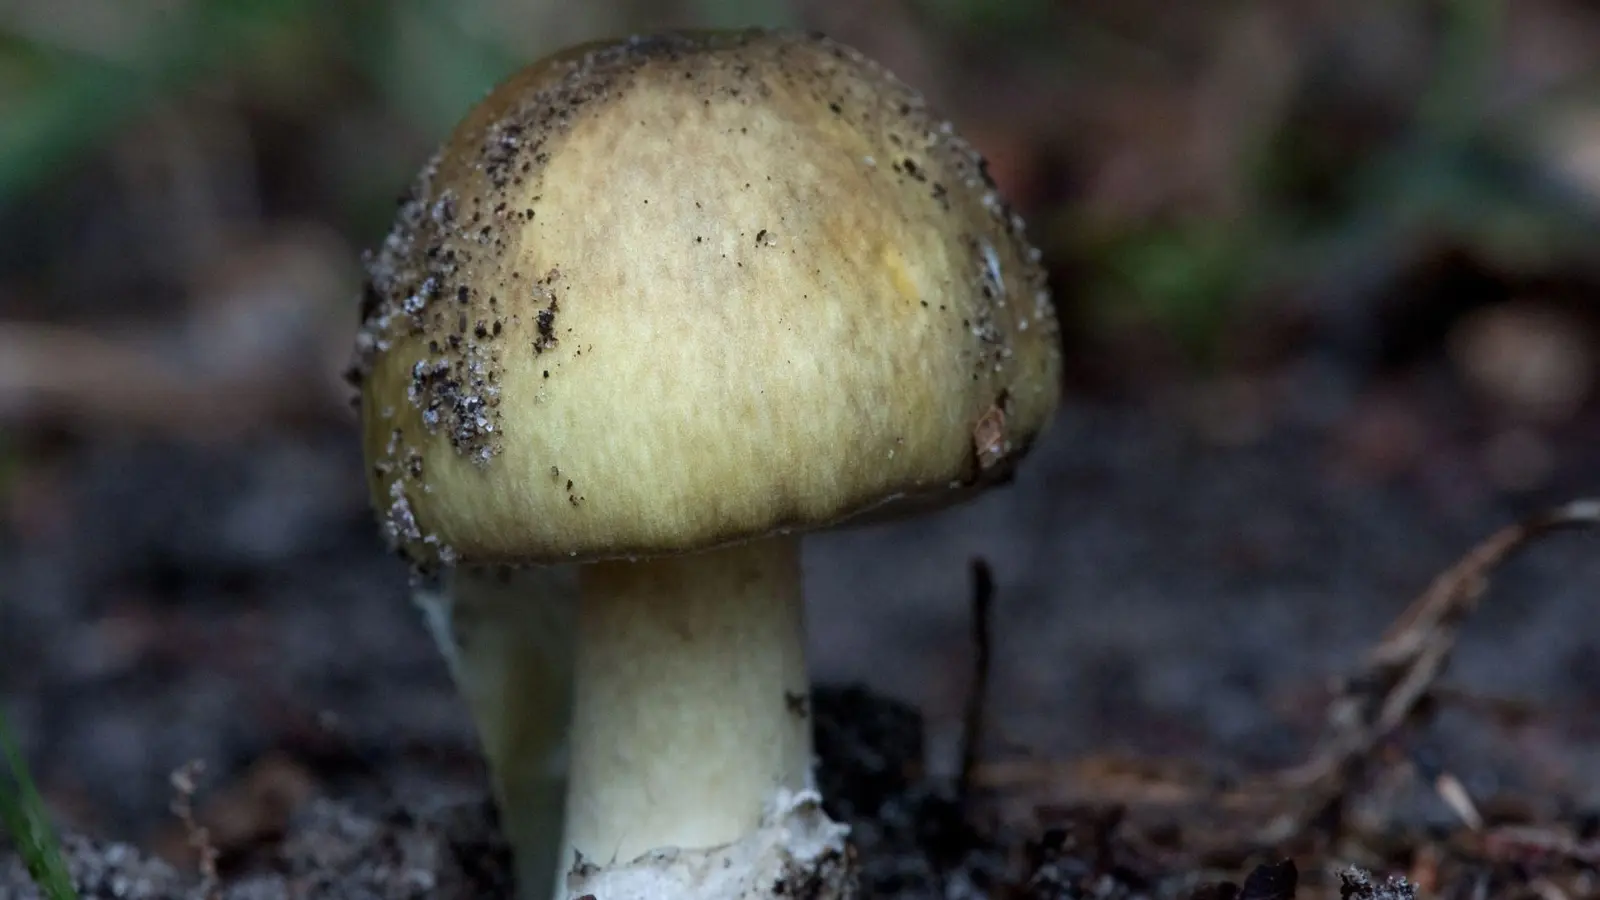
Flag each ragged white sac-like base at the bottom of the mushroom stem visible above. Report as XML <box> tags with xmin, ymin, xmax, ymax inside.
<box><xmin>565</xmin><ymin>790</ymin><xmax>856</xmax><ymax>900</ymax></box>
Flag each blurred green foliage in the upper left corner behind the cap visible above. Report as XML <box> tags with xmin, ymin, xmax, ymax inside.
<box><xmin>0</xmin><ymin>0</ymin><xmax>792</xmax><ymax>237</ymax></box>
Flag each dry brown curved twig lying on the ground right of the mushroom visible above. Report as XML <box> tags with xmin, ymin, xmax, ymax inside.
<box><xmin>973</xmin><ymin>500</ymin><xmax>1600</xmax><ymax>881</ymax></box>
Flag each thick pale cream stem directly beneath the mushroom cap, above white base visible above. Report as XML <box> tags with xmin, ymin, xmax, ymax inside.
<box><xmin>563</xmin><ymin>536</ymin><xmax>811</xmax><ymax>868</ymax></box>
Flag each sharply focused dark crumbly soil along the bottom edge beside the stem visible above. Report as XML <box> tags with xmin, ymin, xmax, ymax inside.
<box><xmin>15</xmin><ymin>672</ymin><xmax>1600</xmax><ymax>900</ymax></box>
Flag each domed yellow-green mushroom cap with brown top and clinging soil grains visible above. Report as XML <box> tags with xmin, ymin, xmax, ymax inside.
<box><xmin>355</xmin><ymin>32</ymin><xmax>1061</xmax><ymax>562</ymax></box>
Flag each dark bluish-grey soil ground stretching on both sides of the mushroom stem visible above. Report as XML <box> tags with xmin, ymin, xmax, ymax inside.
<box><xmin>9</xmin><ymin>389</ymin><xmax>1600</xmax><ymax>897</ymax></box>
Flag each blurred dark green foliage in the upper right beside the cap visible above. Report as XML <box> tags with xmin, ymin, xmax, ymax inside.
<box><xmin>1067</xmin><ymin>0</ymin><xmax>1600</xmax><ymax>367</ymax></box>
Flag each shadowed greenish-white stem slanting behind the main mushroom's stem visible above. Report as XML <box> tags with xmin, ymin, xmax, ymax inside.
<box><xmin>414</xmin><ymin>569</ymin><xmax>576</xmax><ymax>900</ymax></box>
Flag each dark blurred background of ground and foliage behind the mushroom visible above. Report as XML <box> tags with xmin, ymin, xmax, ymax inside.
<box><xmin>0</xmin><ymin>0</ymin><xmax>1600</xmax><ymax>871</ymax></box>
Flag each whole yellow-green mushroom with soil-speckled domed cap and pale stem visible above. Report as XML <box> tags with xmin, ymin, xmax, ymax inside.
<box><xmin>354</xmin><ymin>30</ymin><xmax>1061</xmax><ymax>897</ymax></box>
